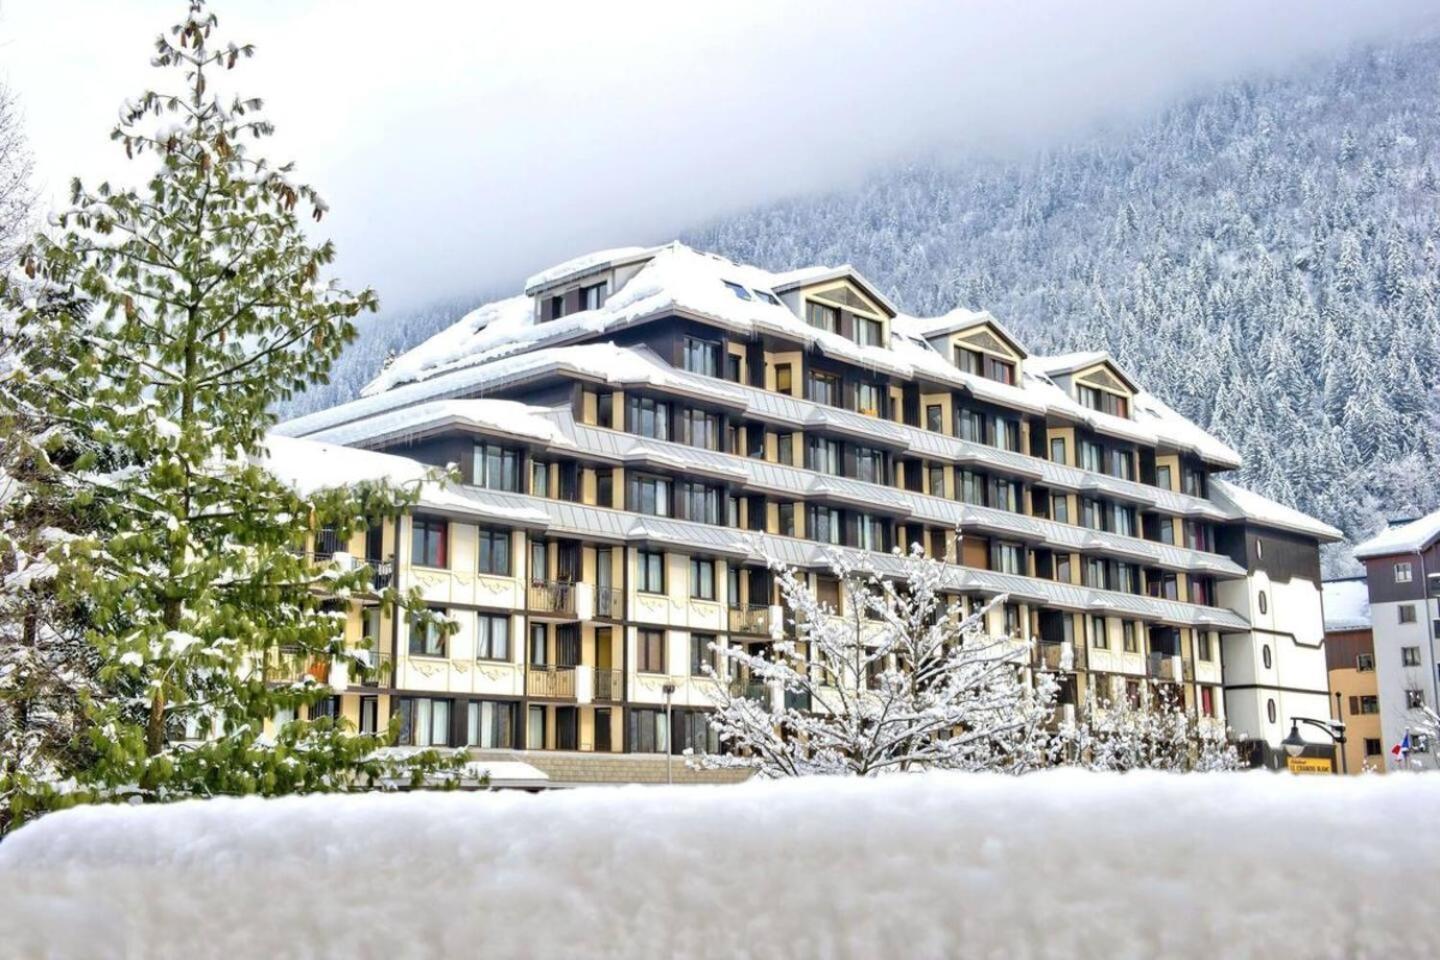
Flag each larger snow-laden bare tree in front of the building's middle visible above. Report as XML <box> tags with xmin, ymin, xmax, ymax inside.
<box><xmin>693</xmin><ymin>548</ymin><xmax>1056</xmax><ymax>777</ymax></box>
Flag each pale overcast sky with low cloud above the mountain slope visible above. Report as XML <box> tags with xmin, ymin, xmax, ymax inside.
<box><xmin>0</xmin><ymin>0</ymin><xmax>1440</xmax><ymax>308</ymax></box>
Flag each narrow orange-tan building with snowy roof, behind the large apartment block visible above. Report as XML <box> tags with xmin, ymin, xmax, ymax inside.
<box><xmin>1325</xmin><ymin>577</ymin><xmax>1388</xmax><ymax>773</ymax></box>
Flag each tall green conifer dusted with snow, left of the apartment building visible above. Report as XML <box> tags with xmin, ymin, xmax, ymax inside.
<box><xmin>7</xmin><ymin>0</ymin><xmax>457</xmax><ymax>829</ymax></box>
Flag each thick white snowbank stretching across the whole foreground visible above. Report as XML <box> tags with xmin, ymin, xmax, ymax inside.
<box><xmin>0</xmin><ymin>771</ymin><xmax>1440</xmax><ymax>960</ymax></box>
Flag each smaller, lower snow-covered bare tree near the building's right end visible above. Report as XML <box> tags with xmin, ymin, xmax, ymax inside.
<box><xmin>1050</xmin><ymin>691</ymin><xmax>1244</xmax><ymax>773</ymax></box>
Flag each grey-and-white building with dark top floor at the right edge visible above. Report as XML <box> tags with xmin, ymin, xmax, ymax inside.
<box><xmin>1355</xmin><ymin>511</ymin><xmax>1440</xmax><ymax>769</ymax></box>
